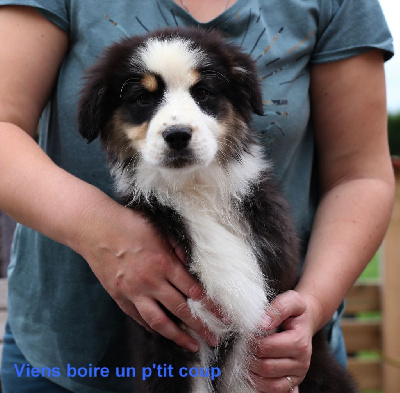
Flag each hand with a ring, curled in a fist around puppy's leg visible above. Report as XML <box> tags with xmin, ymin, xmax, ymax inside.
<box><xmin>249</xmin><ymin>291</ymin><xmax>313</xmax><ymax>393</ymax></box>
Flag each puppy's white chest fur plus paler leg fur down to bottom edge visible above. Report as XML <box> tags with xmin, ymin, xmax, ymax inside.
<box><xmin>180</xmin><ymin>185</ymin><xmax>267</xmax><ymax>393</ymax></box>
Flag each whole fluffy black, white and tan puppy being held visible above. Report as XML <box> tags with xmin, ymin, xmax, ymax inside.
<box><xmin>79</xmin><ymin>29</ymin><xmax>356</xmax><ymax>393</ymax></box>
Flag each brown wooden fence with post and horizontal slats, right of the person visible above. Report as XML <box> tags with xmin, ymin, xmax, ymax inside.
<box><xmin>342</xmin><ymin>160</ymin><xmax>400</xmax><ymax>393</ymax></box>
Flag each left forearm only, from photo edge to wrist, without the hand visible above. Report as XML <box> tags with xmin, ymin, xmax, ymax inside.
<box><xmin>0</xmin><ymin>123</ymin><xmax>119</xmax><ymax>251</ymax></box>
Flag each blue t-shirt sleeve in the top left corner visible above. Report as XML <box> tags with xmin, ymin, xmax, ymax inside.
<box><xmin>0</xmin><ymin>0</ymin><xmax>70</xmax><ymax>32</ymax></box>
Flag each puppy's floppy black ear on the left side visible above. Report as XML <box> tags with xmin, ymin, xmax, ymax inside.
<box><xmin>78</xmin><ymin>69</ymin><xmax>108</xmax><ymax>143</ymax></box>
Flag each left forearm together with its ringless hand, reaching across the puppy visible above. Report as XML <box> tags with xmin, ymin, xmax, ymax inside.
<box><xmin>0</xmin><ymin>122</ymin><xmax>212</xmax><ymax>352</ymax></box>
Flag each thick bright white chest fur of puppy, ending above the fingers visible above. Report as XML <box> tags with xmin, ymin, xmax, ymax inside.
<box><xmin>180</xmin><ymin>194</ymin><xmax>267</xmax><ymax>334</ymax></box>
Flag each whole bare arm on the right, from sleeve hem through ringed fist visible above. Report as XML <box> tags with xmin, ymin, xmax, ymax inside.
<box><xmin>251</xmin><ymin>50</ymin><xmax>394</xmax><ymax>393</ymax></box>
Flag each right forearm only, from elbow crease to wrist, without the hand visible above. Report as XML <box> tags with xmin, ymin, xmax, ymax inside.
<box><xmin>296</xmin><ymin>178</ymin><xmax>394</xmax><ymax>332</ymax></box>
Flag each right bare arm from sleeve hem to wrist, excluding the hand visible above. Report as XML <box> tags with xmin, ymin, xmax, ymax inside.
<box><xmin>296</xmin><ymin>50</ymin><xmax>394</xmax><ymax>333</ymax></box>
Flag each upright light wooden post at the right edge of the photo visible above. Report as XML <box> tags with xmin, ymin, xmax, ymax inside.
<box><xmin>383</xmin><ymin>161</ymin><xmax>400</xmax><ymax>393</ymax></box>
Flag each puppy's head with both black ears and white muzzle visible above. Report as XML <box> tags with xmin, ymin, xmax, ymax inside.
<box><xmin>78</xmin><ymin>29</ymin><xmax>262</xmax><ymax>170</ymax></box>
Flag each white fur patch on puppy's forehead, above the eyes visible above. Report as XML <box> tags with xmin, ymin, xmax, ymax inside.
<box><xmin>137</xmin><ymin>38</ymin><xmax>205</xmax><ymax>87</ymax></box>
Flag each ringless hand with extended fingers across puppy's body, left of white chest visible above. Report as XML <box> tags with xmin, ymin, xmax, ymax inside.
<box><xmin>76</xmin><ymin>206</ymin><xmax>216</xmax><ymax>352</ymax></box>
